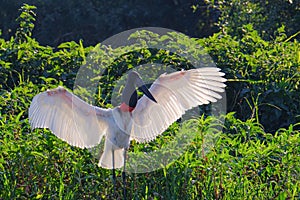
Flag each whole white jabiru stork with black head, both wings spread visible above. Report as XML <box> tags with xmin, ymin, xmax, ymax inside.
<box><xmin>29</xmin><ymin>67</ymin><xmax>226</xmax><ymax>197</ymax></box>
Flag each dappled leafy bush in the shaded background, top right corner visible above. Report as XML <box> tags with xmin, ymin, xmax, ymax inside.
<box><xmin>206</xmin><ymin>0</ymin><xmax>300</xmax><ymax>40</ymax></box>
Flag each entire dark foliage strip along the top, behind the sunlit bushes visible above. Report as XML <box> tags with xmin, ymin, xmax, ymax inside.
<box><xmin>0</xmin><ymin>0</ymin><xmax>300</xmax><ymax>47</ymax></box>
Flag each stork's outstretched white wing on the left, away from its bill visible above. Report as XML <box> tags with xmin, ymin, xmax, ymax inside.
<box><xmin>29</xmin><ymin>86</ymin><xmax>111</xmax><ymax>148</ymax></box>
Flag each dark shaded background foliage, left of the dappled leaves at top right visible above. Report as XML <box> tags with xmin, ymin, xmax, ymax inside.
<box><xmin>0</xmin><ymin>0</ymin><xmax>218</xmax><ymax>46</ymax></box>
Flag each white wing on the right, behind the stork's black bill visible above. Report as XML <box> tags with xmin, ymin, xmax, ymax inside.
<box><xmin>130</xmin><ymin>67</ymin><xmax>226</xmax><ymax>142</ymax></box>
